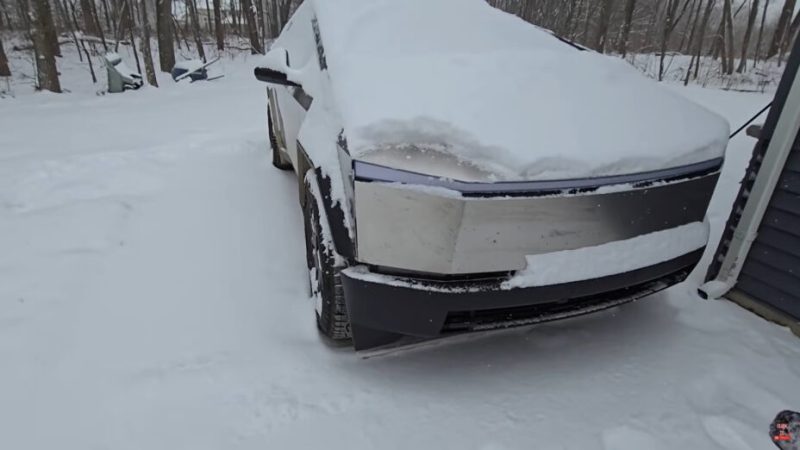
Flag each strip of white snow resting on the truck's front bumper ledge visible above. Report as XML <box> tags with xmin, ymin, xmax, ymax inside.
<box><xmin>503</xmin><ymin>222</ymin><xmax>708</xmax><ymax>289</ymax></box>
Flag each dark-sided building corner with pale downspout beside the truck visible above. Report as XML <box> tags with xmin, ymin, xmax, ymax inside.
<box><xmin>700</xmin><ymin>35</ymin><xmax>800</xmax><ymax>336</ymax></box>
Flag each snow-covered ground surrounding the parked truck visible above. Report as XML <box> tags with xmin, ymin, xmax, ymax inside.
<box><xmin>0</xmin><ymin>49</ymin><xmax>800</xmax><ymax>450</ymax></box>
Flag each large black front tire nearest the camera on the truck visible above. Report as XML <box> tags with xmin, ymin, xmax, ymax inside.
<box><xmin>303</xmin><ymin>176</ymin><xmax>351</xmax><ymax>342</ymax></box>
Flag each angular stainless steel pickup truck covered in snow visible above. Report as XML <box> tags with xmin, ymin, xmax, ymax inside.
<box><xmin>255</xmin><ymin>0</ymin><xmax>729</xmax><ymax>349</ymax></box>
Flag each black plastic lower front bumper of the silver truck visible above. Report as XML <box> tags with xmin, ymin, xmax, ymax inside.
<box><xmin>341</xmin><ymin>249</ymin><xmax>704</xmax><ymax>350</ymax></box>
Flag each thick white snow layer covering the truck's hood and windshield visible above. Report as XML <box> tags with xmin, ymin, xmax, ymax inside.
<box><xmin>313</xmin><ymin>0</ymin><xmax>729</xmax><ymax>179</ymax></box>
